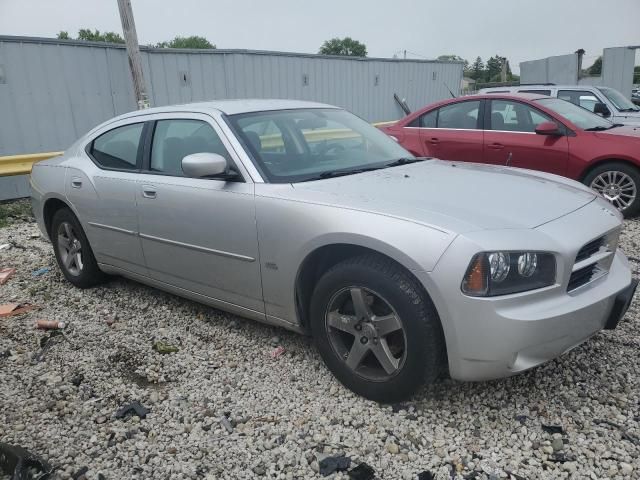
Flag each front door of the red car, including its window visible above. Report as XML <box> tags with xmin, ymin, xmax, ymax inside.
<box><xmin>484</xmin><ymin>100</ymin><xmax>569</xmax><ymax>175</ymax></box>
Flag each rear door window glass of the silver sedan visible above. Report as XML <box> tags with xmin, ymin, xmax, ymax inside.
<box><xmin>90</xmin><ymin>123</ymin><xmax>144</xmax><ymax>170</ymax></box>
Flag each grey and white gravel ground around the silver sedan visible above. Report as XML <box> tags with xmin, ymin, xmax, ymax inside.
<box><xmin>0</xmin><ymin>208</ymin><xmax>640</xmax><ymax>480</ymax></box>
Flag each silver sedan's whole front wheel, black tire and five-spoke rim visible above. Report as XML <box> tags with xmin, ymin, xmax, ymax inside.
<box><xmin>311</xmin><ymin>254</ymin><xmax>444</xmax><ymax>402</ymax></box>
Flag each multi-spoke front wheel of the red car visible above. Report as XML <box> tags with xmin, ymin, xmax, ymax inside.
<box><xmin>584</xmin><ymin>162</ymin><xmax>640</xmax><ymax>218</ymax></box>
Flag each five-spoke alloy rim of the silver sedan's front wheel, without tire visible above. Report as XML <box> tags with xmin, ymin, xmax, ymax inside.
<box><xmin>325</xmin><ymin>286</ymin><xmax>407</xmax><ymax>381</ymax></box>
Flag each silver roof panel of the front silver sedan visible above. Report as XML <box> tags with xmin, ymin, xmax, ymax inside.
<box><xmin>113</xmin><ymin>98</ymin><xmax>339</xmax><ymax>120</ymax></box>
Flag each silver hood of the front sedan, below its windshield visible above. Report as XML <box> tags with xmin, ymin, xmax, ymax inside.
<box><xmin>287</xmin><ymin>160</ymin><xmax>595</xmax><ymax>233</ymax></box>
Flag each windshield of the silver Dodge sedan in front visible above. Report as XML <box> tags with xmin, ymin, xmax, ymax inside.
<box><xmin>229</xmin><ymin>108</ymin><xmax>415</xmax><ymax>183</ymax></box>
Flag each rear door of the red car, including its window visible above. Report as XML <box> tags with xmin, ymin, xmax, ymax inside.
<box><xmin>419</xmin><ymin>100</ymin><xmax>483</xmax><ymax>162</ymax></box>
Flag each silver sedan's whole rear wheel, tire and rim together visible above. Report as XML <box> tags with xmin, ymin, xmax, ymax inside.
<box><xmin>51</xmin><ymin>208</ymin><xmax>105</xmax><ymax>288</ymax></box>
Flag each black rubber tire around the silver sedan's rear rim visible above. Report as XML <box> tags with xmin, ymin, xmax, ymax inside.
<box><xmin>51</xmin><ymin>208</ymin><xmax>106</xmax><ymax>288</ymax></box>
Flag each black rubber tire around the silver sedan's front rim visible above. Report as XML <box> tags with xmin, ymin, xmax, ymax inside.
<box><xmin>310</xmin><ymin>254</ymin><xmax>445</xmax><ymax>403</ymax></box>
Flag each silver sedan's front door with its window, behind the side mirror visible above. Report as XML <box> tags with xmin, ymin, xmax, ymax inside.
<box><xmin>137</xmin><ymin>113</ymin><xmax>264</xmax><ymax>314</ymax></box>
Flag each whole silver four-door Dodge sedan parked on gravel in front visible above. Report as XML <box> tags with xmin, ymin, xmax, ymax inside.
<box><xmin>31</xmin><ymin>100</ymin><xmax>636</xmax><ymax>401</ymax></box>
